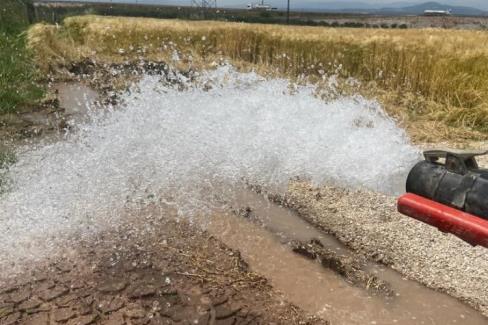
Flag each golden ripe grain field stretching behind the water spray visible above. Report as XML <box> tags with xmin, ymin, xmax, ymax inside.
<box><xmin>28</xmin><ymin>16</ymin><xmax>488</xmax><ymax>140</ymax></box>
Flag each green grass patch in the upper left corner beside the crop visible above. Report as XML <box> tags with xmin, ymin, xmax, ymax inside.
<box><xmin>0</xmin><ymin>0</ymin><xmax>43</xmax><ymax>114</ymax></box>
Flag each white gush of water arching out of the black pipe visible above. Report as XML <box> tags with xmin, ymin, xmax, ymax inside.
<box><xmin>0</xmin><ymin>66</ymin><xmax>418</xmax><ymax>273</ymax></box>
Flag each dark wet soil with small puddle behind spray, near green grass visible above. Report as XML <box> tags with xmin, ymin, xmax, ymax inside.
<box><xmin>0</xmin><ymin>60</ymin><xmax>171</xmax><ymax>143</ymax></box>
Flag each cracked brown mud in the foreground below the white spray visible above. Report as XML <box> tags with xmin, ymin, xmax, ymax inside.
<box><xmin>0</xmin><ymin>213</ymin><xmax>327</xmax><ymax>325</ymax></box>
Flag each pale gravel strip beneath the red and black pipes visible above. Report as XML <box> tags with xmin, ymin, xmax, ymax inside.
<box><xmin>275</xmin><ymin>182</ymin><xmax>488</xmax><ymax>316</ymax></box>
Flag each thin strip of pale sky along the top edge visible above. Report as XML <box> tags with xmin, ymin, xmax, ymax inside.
<box><xmin>43</xmin><ymin>0</ymin><xmax>488</xmax><ymax>10</ymax></box>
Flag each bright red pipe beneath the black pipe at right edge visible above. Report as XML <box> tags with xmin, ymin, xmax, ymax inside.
<box><xmin>398</xmin><ymin>193</ymin><xmax>488</xmax><ymax>248</ymax></box>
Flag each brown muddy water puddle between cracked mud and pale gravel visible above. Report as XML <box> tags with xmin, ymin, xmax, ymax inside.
<box><xmin>208</xmin><ymin>190</ymin><xmax>487</xmax><ymax>325</ymax></box>
